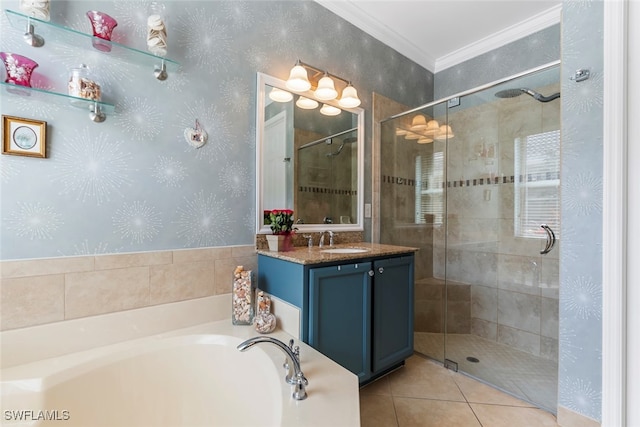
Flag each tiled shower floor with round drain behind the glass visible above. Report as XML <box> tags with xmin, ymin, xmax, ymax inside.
<box><xmin>414</xmin><ymin>332</ymin><xmax>558</xmax><ymax>414</ymax></box>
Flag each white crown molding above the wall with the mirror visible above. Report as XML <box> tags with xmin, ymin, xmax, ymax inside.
<box><xmin>315</xmin><ymin>0</ymin><xmax>436</xmax><ymax>71</ymax></box>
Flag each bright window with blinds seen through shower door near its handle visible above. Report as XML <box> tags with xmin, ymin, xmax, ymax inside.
<box><xmin>514</xmin><ymin>130</ymin><xmax>560</xmax><ymax>239</ymax></box>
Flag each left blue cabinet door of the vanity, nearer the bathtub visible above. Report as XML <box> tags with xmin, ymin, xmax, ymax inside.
<box><xmin>309</xmin><ymin>262</ymin><xmax>371</xmax><ymax>382</ymax></box>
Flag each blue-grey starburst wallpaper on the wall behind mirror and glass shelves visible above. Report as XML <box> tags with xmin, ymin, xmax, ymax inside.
<box><xmin>0</xmin><ymin>0</ymin><xmax>433</xmax><ymax>260</ymax></box>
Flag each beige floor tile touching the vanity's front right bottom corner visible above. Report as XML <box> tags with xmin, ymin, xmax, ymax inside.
<box><xmin>389</xmin><ymin>356</ymin><xmax>466</xmax><ymax>402</ymax></box>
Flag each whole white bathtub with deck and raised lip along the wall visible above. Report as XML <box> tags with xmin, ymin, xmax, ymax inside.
<box><xmin>0</xmin><ymin>294</ymin><xmax>360</xmax><ymax>427</ymax></box>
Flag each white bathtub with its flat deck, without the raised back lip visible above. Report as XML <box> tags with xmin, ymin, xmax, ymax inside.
<box><xmin>0</xmin><ymin>298</ymin><xmax>360</xmax><ymax>427</ymax></box>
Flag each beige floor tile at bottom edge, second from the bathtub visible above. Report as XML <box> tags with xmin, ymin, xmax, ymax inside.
<box><xmin>394</xmin><ymin>397</ymin><xmax>482</xmax><ymax>427</ymax></box>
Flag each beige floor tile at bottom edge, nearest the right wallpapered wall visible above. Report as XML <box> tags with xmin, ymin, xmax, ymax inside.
<box><xmin>471</xmin><ymin>403</ymin><xmax>558</xmax><ymax>427</ymax></box>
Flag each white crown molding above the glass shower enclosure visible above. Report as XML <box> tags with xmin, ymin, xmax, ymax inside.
<box><xmin>434</xmin><ymin>5</ymin><xmax>562</xmax><ymax>73</ymax></box>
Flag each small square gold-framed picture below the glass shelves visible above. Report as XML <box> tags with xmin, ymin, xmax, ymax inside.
<box><xmin>2</xmin><ymin>115</ymin><xmax>47</xmax><ymax>158</ymax></box>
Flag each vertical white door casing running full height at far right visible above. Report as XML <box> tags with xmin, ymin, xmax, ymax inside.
<box><xmin>601</xmin><ymin>1</ymin><xmax>627</xmax><ymax>427</ymax></box>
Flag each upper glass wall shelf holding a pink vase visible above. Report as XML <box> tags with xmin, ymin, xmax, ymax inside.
<box><xmin>5</xmin><ymin>9</ymin><xmax>180</xmax><ymax>80</ymax></box>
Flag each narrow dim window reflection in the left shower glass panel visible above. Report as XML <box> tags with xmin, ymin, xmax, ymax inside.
<box><xmin>415</xmin><ymin>151</ymin><xmax>444</xmax><ymax>224</ymax></box>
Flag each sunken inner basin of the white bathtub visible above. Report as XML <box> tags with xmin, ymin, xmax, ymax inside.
<box><xmin>2</xmin><ymin>335</ymin><xmax>284</xmax><ymax>427</ymax></box>
